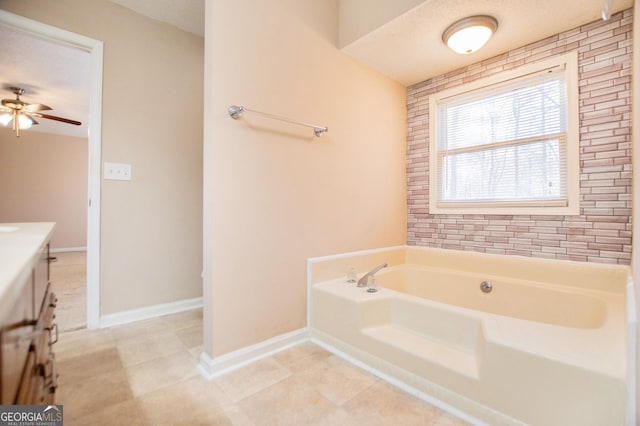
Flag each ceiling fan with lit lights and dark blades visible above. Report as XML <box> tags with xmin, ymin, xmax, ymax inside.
<box><xmin>0</xmin><ymin>87</ymin><xmax>82</xmax><ymax>137</ymax></box>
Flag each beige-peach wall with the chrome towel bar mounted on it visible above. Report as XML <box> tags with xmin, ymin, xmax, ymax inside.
<box><xmin>204</xmin><ymin>0</ymin><xmax>406</xmax><ymax>357</ymax></box>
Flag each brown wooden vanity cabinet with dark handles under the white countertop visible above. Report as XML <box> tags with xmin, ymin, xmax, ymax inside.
<box><xmin>0</xmin><ymin>244</ymin><xmax>57</xmax><ymax>405</ymax></box>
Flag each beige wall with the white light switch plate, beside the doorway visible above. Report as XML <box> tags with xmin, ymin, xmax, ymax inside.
<box><xmin>0</xmin><ymin>0</ymin><xmax>204</xmax><ymax>314</ymax></box>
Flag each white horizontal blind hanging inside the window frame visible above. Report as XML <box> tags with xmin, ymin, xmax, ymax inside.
<box><xmin>431</xmin><ymin>68</ymin><xmax>568</xmax><ymax>207</ymax></box>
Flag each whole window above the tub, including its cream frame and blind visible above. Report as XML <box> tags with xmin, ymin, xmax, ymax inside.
<box><xmin>429</xmin><ymin>53</ymin><xmax>580</xmax><ymax>215</ymax></box>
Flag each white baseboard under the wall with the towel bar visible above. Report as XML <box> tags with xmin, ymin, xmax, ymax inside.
<box><xmin>198</xmin><ymin>327</ymin><xmax>309</xmax><ymax>380</ymax></box>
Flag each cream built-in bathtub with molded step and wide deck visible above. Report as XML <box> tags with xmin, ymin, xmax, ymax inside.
<box><xmin>309</xmin><ymin>246</ymin><xmax>635</xmax><ymax>426</ymax></box>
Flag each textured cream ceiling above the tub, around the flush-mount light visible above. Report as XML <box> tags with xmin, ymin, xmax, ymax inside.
<box><xmin>342</xmin><ymin>0</ymin><xmax>633</xmax><ymax>85</ymax></box>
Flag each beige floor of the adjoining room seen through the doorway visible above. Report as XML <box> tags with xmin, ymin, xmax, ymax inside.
<box><xmin>50</xmin><ymin>251</ymin><xmax>87</xmax><ymax>331</ymax></box>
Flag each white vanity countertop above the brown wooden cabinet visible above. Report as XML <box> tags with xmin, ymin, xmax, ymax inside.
<box><xmin>0</xmin><ymin>222</ymin><xmax>56</xmax><ymax>316</ymax></box>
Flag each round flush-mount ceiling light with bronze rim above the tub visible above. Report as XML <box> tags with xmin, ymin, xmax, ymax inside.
<box><xmin>442</xmin><ymin>15</ymin><xmax>498</xmax><ymax>55</ymax></box>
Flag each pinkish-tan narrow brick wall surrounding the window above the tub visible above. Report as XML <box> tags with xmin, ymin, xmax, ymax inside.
<box><xmin>407</xmin><ymin>9</ymin><xmax>633</xmax><ymax>264</ymax></box>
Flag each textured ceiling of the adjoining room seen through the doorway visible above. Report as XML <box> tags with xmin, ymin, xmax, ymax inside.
<box><xmin>0</xmin><ymin>25</ymin><xmax>90</xmax><ymax>137</ymax></box>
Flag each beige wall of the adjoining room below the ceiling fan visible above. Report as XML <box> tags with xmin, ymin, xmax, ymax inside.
<box><xmin>0</xmin><ymin>127</ymin><xmax>88</xmax><ymax>249</ymax></box>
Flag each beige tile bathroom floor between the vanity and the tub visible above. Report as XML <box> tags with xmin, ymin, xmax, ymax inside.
<box><xmin>55</xmin><ymin>310</ymin><xmax>466</xmax><ymax>426</ymax></box>
